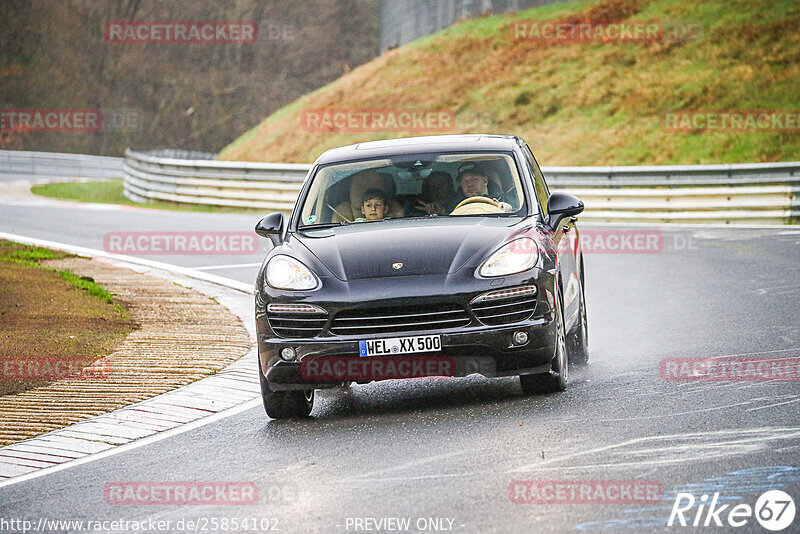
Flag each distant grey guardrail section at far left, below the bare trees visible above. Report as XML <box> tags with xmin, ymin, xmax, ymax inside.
<box><xmin>0</xmin><ymin>150</ymin><xmax>124</xmax><ymax>178</ymax></box>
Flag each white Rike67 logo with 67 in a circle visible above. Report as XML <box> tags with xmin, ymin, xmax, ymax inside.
<box><xmin>667</xmin><ymin>490</ymin><xmax>796</xmax><ymax>532</ymax></box>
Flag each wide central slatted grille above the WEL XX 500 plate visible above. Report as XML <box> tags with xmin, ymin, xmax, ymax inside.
<box><xmin>331</xmin><ymin>304</ymin><xmax>470</xmax><ymax>336</ymax></box>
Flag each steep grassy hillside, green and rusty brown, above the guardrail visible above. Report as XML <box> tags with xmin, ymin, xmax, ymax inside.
<box><xmin>220</xmin><ymin>0</ymin><xmax>800</xmax><ymax>165</ymax></box>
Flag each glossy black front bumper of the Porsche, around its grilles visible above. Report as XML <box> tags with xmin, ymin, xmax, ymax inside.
<box><xmin>256</xmin><ymin>269</ymin><xmax>556</xmax><ymax>391</ymax></box>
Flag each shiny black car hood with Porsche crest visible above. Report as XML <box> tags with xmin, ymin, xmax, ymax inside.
<box><xmin>293</xmin><ymin>217</ymin><xmax>524</xmax><ymax>280</ymax></box>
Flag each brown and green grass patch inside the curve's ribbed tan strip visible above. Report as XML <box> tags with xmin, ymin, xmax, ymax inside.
<box><xmin>0</xmin><ymin>240</ymin><xmax>135</xmax><ymax>395</ymax></box>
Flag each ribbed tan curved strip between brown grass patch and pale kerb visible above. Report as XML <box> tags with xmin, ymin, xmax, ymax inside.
<box><xmin>0</xmin><ymin>258</ymin><xmax>251</xmax><ymax>446</ymax></box>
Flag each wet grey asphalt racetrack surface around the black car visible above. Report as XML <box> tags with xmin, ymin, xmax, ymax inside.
<box><xmin>0</xmin><ymin>194</ymin><xmax>800</xmax><ymax>533</ymax></box>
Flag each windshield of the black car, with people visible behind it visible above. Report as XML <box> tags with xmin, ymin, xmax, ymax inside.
<box><xmin>300</xmin><ymin>152</ymin><xmax>525</xmax><ymax>227</ymax></box>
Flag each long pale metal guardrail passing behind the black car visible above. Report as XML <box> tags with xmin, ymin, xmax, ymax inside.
<box><xmin>123</xmin><ymin>150</ymin><xmax>800</xmax><ymax>224</ymax></box>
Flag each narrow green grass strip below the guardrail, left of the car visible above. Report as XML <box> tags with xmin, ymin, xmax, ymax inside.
<box><xmin>31</xmin><ymin>178</ymin><xmax>264</xmax><ymax>213</ymax></box>
